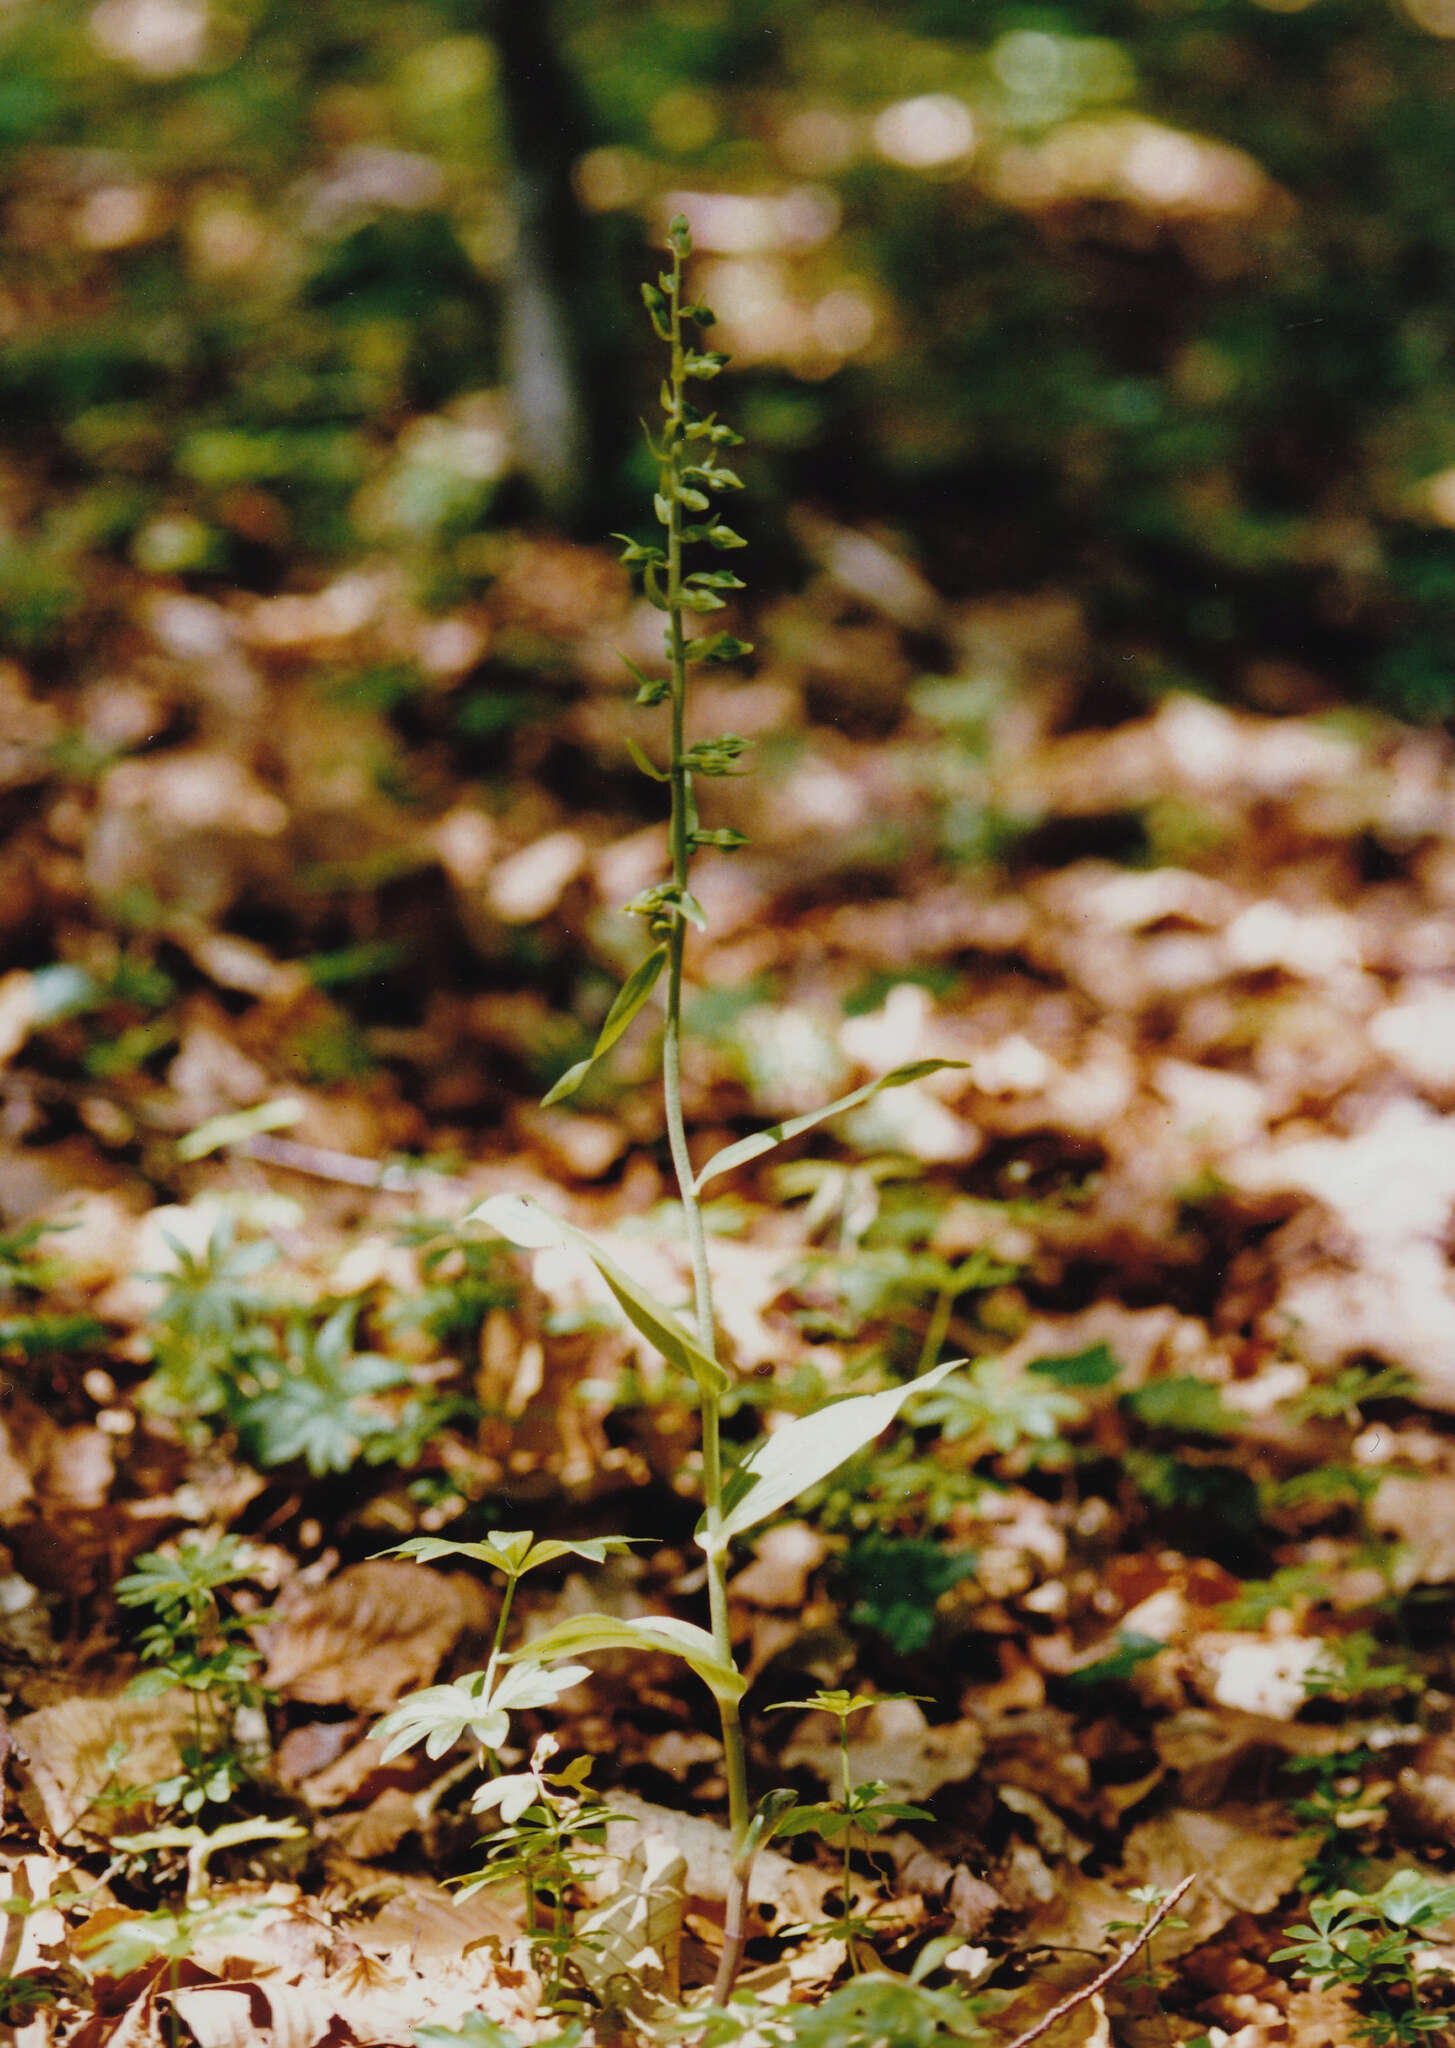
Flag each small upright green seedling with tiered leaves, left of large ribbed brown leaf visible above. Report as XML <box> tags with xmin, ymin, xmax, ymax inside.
<box><xmin>117</xmin><ymin>1536</ymin><xmax>264</xmax><ymax>1812</ymax></box>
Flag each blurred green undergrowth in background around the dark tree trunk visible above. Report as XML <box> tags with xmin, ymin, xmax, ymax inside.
<box><xmin>0</xmin><ymin>0</ymin><xmax>1455</xmax><ymax>715</ymax></box>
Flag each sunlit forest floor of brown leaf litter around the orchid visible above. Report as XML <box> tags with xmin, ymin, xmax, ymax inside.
<box><xmin>0</xmin><ymin>522</ymin><xmax>1455</xmax><ymax>2048</ymax></box>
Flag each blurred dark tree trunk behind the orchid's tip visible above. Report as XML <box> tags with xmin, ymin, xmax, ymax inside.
<box><xmin>488</xmin><ymin>0</ymin><xmax>623</xmax><ymax>528</ymax></box>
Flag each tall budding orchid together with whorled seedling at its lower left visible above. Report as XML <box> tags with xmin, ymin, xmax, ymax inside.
<box><xmin>372</xmin><ymin>215</ymin><xmax>963</xmax><ymax>2003</ymax></box>
